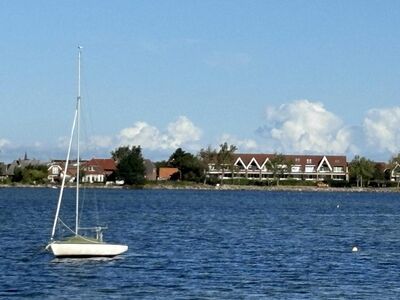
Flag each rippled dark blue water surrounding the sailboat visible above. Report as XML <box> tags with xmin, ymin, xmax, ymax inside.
<box><xmin>0</xmin><ymin>188</ymin><xmax>400</xmax><ymax>299</ymax></box>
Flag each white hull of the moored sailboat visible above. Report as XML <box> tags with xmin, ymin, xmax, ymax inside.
<box><xmin>50</xmin><ymin>242</ymin><xmax>128</xmax><ymax>257</ymax></box>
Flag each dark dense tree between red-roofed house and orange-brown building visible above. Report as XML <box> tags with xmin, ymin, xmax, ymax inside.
<box><xmin>111</xmin><ymin>146</ymin><xmax>146</xmax><ymax>185</ymax></box>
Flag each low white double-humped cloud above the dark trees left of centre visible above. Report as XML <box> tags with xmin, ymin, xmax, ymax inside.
<box><xmin>118</xmin><ymin>116</ymin><xmax>201</xmax><ymax>150</ymax></box>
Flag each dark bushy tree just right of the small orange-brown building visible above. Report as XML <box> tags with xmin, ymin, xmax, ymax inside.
<box><xmin>168</xmin><ymin>148</ymin><xmax>203</xmax><ymax>181</ymax></box>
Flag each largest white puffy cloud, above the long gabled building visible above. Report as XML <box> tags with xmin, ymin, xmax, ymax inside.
<box><xmin>258</xmin><ymin>100</ymin><xmax>352</xmax><ymax>154</ymax></box>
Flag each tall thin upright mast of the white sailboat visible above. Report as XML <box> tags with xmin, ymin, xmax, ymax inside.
<box><xmin>75</xmin><ymin>46</ymin><xmax>82</xmax><ymax>235</ymax></box>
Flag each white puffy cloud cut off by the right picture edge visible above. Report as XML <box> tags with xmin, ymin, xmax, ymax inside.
<box><xmin>363</xmin><ymin>107</ymin><xmax>400</xmax><ymax>154</ymax></box>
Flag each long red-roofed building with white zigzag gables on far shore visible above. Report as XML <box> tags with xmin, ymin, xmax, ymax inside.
<box><xmin>208</xmin><ymin>153</ymin><xmax>349</xmax><ymax>181</ymax></box>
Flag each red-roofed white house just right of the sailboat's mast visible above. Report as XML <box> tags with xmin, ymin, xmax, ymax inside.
<box><xmin>82</xmin><ymin>158</ymin><xmax>117</xmax><ymax>183</ymax></box>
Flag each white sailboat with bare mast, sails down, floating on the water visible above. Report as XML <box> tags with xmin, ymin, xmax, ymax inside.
<box><xmin>46</xmin><ymin>46</ymin><xmax>128</xmax><ymax>258</ymax></box>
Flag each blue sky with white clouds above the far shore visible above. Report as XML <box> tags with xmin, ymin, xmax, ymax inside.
<box><xmin>0</xmin><ymin>0</ymin><xmax>400</xmax><ymax>162</ymax></box>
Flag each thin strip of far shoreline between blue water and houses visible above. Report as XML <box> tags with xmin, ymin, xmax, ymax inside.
<box><xmin>0</xmin><ymin>184</ymin><xmax>400</xmax><ymax>193</ymax></box>
